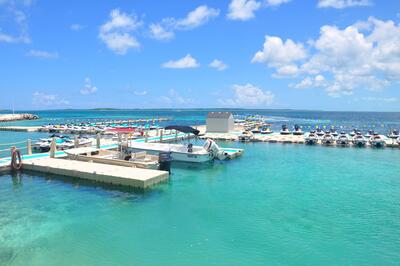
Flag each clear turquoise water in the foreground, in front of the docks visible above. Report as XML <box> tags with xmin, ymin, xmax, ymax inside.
<box><xmin>0</xmin><ymin>143</ymin><xmax>400</xmax><ymax>265</ymax></box>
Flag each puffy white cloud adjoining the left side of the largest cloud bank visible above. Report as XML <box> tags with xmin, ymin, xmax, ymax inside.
<box><xmin>251</xmin><ymin>35</ymin><xmax>307</xmax><ymax>76</ymax></box>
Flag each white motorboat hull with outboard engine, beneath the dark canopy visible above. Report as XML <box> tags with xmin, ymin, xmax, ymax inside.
<box><xmin>122</xmin><ymin>139</ymin><xmax>228</xmax><ymax>163</ymax></box>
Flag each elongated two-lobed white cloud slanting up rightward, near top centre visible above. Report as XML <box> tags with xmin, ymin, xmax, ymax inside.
<box><xmin>149</xmin><ymin>5</ymin><xmax>220</xmax><ymax>41</ymax></box>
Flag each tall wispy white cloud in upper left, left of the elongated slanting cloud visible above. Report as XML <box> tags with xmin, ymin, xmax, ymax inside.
<box><xmin>99</xmin><ymin>9</ymin><xmax>143</xmax><ymax>55</ymax></box>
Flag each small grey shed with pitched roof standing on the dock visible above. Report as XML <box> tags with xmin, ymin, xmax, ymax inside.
<box><xmin>206</xmin><ymin>112</ymin><xmax>235</xmax><ymax>133</ymax></box>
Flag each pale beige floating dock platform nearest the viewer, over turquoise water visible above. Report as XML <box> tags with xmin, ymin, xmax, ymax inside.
<box><xmin>23</xmin><ymin>158</ymin><xmax>169</xmax><ymax>189</ymax></box>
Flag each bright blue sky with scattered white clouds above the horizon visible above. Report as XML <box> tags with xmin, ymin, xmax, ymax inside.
<box><xmin>0</xmin><ymin>0</ymin><xmax>400</xmax><ymax>111</ymax></box>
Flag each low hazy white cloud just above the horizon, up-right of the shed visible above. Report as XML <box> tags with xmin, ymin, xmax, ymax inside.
<box><xmin>219</xmin><ymin>83</ymin><xmax>275</xmax><ymax>107</ymax></box>
